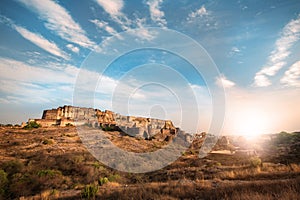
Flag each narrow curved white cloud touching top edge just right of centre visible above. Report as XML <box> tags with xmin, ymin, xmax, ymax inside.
<box><xmin>147</xmin><ymin>0</ymin><xmax>167</xmax><ymax>27</ymax></box>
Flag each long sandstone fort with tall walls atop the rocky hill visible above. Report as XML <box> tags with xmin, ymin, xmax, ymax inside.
<box><xmin>29</xmin><ymin>105</ymin><xmax>180</xmax><ymax>140</ymax></box>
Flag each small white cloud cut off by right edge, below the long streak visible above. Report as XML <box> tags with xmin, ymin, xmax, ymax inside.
<box><xmin>280</xmin><ymin>61</ymin><xmax>300</xmax><ymax>87</ymax></box>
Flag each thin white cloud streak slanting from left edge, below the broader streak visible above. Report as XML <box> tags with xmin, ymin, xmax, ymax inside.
<box><xmin>0</xmin><ymin>16</ymin><xmax>70</xmax><ymax>60</ymax></box>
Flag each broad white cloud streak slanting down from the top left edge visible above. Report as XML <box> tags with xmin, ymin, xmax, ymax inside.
<box><xmin>19</xmin><ymin>0</ymin><xmax>95</xmax><ymax>48</ymax></box>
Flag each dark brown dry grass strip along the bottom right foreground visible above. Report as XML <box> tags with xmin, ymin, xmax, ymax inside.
<box><xmin>94</xmin><ymin>179</ymin><xmax>300</xmax><ymax>200</ymax></box>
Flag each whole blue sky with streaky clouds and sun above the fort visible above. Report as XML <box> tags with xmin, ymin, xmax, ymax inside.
<box><xmin>0</xmin><ymin>0</ymin><xmax>300</xmax><ymax>136</ymax></box>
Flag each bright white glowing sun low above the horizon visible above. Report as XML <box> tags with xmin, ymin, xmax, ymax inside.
<box><xmin>235</xmin><ymin>109</ymin><xmax>270</xmax><ymax>139</ymax></box>
